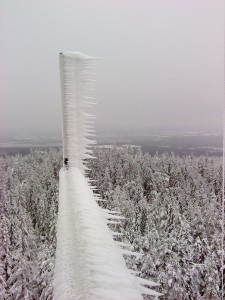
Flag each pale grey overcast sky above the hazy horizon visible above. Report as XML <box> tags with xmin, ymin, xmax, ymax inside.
<box><xmin>0</xmin><ymin>0</ymin><xmax>224</xmax><ymax>136</ymax></box>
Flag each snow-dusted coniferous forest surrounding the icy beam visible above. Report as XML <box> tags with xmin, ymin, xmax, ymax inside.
<box><xmin>0</xmin><ymin>147</ymin><xmax>222</xmax><ymax>300</ymax></box>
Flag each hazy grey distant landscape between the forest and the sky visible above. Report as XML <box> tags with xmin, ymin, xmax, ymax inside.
<box><xmin>0</xmin><ymin>133</ymin><xmax>223</xmax><ymax>156</ymax></box>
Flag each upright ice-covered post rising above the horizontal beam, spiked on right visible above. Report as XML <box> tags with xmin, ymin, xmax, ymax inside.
<box><xmin>60</xmin><ymin>51</ymin><xmax>94</xmax><ymax>169</ymax></box>
